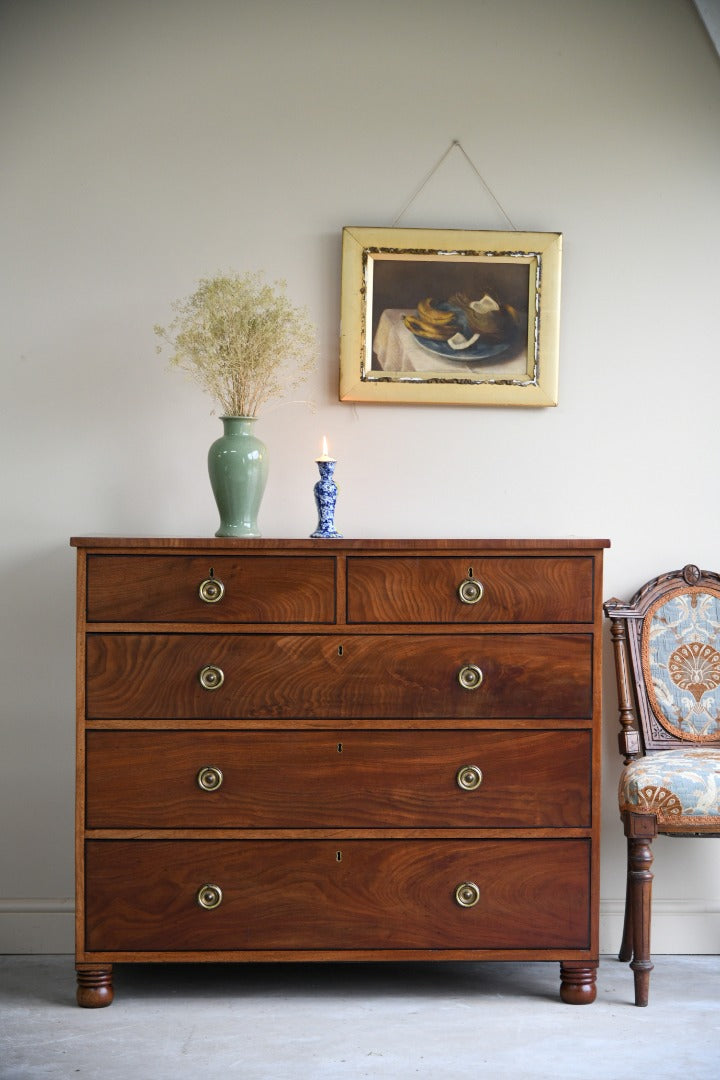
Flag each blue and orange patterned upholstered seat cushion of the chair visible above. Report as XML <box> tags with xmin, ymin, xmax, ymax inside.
<box><xmin>617</xmin><ymin>748</ymin><xmax>720</xmax><ymax>832</ymax></box>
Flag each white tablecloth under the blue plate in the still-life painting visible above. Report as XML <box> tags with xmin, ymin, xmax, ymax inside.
<box><xmin>372</xmin><ymin>308</ymin><xmax>526</xmax><ymax>379</ymax></box>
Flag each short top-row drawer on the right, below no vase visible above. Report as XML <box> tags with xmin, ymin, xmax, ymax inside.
<box><xmin>348</xmin><ymin>555</ymin><xmax>593</xmax><ymax>624</ymax></box>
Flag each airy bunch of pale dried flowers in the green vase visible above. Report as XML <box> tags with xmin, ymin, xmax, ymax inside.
<box><xmin>154</xmin><ymin>273</ymin><xmax>316</xmax><ymax>416</ymax></box>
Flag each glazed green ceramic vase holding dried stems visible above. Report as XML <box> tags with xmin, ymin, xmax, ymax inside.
<box><xmin>207</xmin><ymin>416</ymin><xmax>269</xmax><ymax>537</ymax></box>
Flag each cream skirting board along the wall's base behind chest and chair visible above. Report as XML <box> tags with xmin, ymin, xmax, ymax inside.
<box><xmin>0</xmin><ymin>897</ymin><xmax>720</xmax><ymax>956</ymax></box>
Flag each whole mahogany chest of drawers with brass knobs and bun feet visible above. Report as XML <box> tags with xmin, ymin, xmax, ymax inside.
<box><xmin>71</xmin><ymin>538</ymin><xmax>607</xmax><ymax>1008</ymax></box>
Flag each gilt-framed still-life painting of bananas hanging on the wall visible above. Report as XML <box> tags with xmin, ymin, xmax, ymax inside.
<box><xmin>340</xmin><ymin>226</ymin><xmax>562</xmax><ymax>406</ymax></box>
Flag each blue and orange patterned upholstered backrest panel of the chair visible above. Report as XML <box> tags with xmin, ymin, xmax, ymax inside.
<box><xmin>642</xmin><ymin>588</ymin><xmax>720</xmax><ymax>743</ymax></box>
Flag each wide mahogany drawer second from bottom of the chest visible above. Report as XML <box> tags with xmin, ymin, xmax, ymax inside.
<box><xmin>86</xmin><ymin>729</ymin><xmax>590</xmax><ymax>828</ymax></box>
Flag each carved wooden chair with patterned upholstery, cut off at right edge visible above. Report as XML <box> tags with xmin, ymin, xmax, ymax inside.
<box><xmin>604</xmin><ymin>565</ymin><xmax>720</xmax><ymax>1005</ymax></box>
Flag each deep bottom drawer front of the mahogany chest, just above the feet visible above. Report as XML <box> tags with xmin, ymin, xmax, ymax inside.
<box><xmin>85</xmin><ymin>839</ymin><xmax>589</xmax><ymax>951</ymax></box>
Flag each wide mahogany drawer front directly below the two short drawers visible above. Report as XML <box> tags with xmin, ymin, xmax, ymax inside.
<box><xmin>86</xmin><ymin>634</ymin><xmax>593</xmax><ymax>720</ymax></box>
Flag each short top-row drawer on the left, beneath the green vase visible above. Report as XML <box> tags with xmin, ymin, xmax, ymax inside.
<box><xmin>87</xmin><ymin>555</ymin><xmax>336</xmax><ymax>623</ymax></box>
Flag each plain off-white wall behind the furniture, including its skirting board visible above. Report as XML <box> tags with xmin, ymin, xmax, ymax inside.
<box><xmin>0</xmin><ymin>0</ymin><xmax>720</xmax><ymax>951</ymax></box>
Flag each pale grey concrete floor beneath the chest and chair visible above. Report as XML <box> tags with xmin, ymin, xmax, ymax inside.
<box><xmin>0</xmin><ymin>956</ymin><xmax>720</xmax><ymax>1080</ymax></box>
